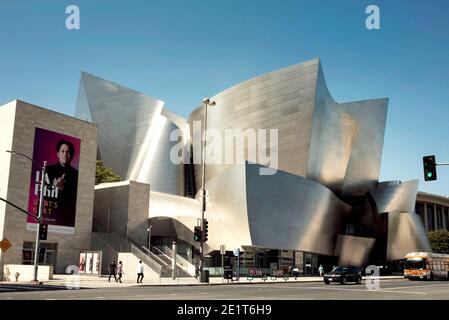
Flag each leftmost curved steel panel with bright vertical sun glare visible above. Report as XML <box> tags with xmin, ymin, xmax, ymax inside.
<box><xmin>76</xmin><ymin>72</ymin><xmax>188</xmax><ymax>195</ymax></box>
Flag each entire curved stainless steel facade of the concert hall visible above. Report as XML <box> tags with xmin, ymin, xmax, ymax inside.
<box><xmin>77</xmin><ymin>59</ymin><xmax>429</xmax><ymax>265</ymax></box>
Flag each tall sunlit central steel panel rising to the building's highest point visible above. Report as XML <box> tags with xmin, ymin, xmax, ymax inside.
<box><xmin>189</xmin><ymin>59</ymin><xmax>319</xmax><ymax>190</ymax></box>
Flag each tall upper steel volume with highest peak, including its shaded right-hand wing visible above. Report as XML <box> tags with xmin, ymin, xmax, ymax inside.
<box><xmin>189</xmin><ymin>59</ymin><xmax>388</xmax><ymax>196</ymax></box>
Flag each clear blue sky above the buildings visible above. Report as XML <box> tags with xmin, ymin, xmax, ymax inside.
<box><xmin>0</xmin><ymin>0</ymin><xmax>449</xmax><ymax>195</ymax></box>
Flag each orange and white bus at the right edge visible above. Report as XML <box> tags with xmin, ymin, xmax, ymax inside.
<box><xmin>404</xmin><ymin>252</ymin><xmax>449</xmax><ymax>280</ymax></box>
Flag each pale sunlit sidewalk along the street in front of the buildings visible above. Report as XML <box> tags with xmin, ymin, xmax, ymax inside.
<box><xmin>28</xmin><ymin>274</ymin><xmax>404</xmax><ymax>288</ymax></box>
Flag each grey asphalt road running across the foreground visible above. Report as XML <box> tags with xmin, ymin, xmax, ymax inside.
<box><xmin>0</xmin><ymin>279</ymin><xmax>449</xmax><ymax>300</ymax></box>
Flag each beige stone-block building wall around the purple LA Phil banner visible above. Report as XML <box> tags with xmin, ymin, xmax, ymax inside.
<box><xmin>0</xmin><ymin>100</ymin><xmax>97</xmax><ymax>273</ymax></box>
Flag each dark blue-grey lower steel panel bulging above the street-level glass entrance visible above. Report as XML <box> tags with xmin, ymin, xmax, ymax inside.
<box><xmin>245</xmin><ymin>165</ymin><xmax>350</xmax><ymax>255</ymax></box>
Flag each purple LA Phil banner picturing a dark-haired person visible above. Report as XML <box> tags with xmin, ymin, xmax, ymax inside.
<box><xmin>27</xmin><ymin>128</ymin><xmax>81</xmax><ymax>230</ymax></box>
